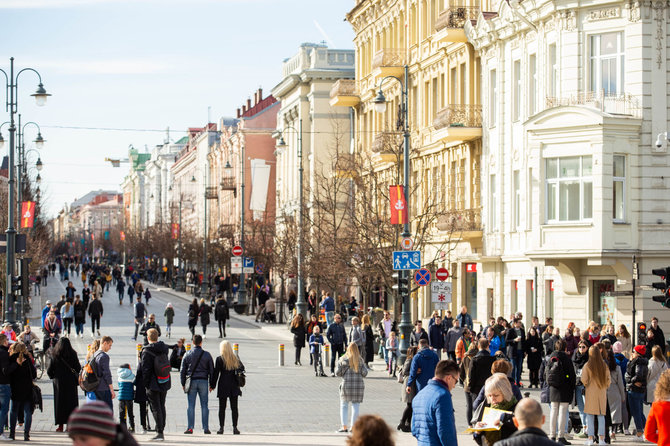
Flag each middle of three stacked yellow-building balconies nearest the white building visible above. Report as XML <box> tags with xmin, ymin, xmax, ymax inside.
<box><xmin>433</xmin><ymin>104</ymin><xmax>482</xmax><ymax>142</ymax></box>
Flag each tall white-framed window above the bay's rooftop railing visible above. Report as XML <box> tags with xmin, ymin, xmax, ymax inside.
<box><xmin>591</xmin><ymin>32</ymin><xmax>624</xmax><ymax>95</ymax></box>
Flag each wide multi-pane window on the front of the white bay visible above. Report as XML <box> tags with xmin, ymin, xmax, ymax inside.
<box><xmin>546</xmin><ymin>156</ymin><xmax>593</xmax><ymax>222</ymax></box>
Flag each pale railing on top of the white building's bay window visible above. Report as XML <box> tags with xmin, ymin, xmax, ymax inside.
<box><xmin>545</xmin><ymin>90</ymin><xmax>642</xmax><ymax>118</ymax></box>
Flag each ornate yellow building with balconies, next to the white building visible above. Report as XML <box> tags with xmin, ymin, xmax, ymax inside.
<box><xmin>338</xmin><ymin>0</ymin><xmax>490</xmax><ymax>318</ymax></box>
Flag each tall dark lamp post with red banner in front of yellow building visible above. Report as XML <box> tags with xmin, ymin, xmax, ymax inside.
<box><xmin>373</xmin><ymin>65</ymin><xmax>412</xmax><ymax>362</ymax></box>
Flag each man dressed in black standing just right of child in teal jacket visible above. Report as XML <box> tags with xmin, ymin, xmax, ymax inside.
<box><xmin>140</xmin><ymin>328</ymin><xmax>172</xmax><ymax>441</ymax></box>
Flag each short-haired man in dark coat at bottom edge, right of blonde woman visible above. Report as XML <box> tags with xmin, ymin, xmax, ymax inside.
<box><xmin>496</xmin><ymin>398</ymin><xmax>561</xmax><ymax>446</ymax></box>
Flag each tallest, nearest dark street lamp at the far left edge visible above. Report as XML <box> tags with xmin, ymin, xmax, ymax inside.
<box><xmin>0</xmin><ymin>57</ymin><xmax>50</xmax><ymax>324</ymax></box>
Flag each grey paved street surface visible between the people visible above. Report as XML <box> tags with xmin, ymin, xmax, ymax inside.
<box><xmin>27</xmin><ymin>276</ymin><xmax>656</xmax><ymax>446</ymax></box>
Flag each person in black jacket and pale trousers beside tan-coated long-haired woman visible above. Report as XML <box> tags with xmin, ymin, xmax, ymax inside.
<box><xmin>545</xmin><ymin>339</ymin><xmax>576</xmax><ymax>444</ymax></box>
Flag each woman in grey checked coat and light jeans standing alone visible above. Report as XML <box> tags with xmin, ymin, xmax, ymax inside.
<box><xmin>335</xmin><ymin>343</ymin><xmax>368</xmax><ymax>432</ymax></box>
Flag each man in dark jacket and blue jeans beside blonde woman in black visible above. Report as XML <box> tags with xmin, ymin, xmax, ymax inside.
<box><xmin>179</xmin><ymin>335</ymin><xmax>214</xmax><ymax>434</ymax></box>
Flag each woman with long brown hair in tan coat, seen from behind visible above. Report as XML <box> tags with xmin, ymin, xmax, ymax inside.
<box><xmin>581</xmin><ymin>345</ymin><xmax>611</xmax><ymax>445</ymax></box>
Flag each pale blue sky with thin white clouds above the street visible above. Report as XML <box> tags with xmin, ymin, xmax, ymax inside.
<box><xmin>0</xmin><ymin>0</ymin><xmax>355</xmax><ymax>216</ymax></box>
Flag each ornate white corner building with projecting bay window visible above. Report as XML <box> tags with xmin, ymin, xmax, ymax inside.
<box><xmin>466</xmin><ymin>0</ymin><xmax>670</xmax><ymax>329</ymax></box>
